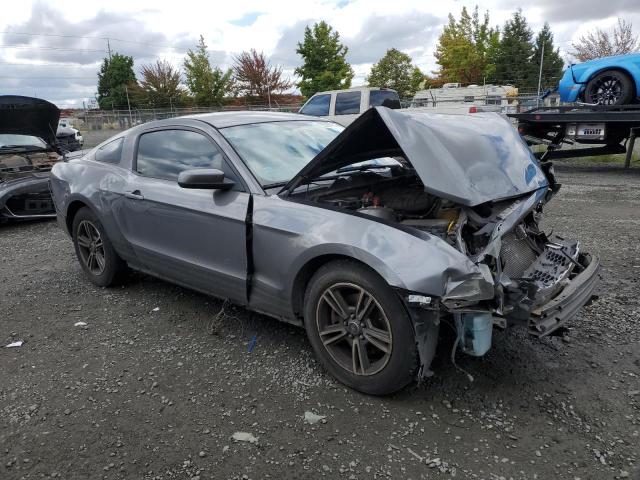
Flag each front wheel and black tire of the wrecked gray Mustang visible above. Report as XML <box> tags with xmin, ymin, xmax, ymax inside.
<box><xmin>304</xmin><ymin>260</ymin><xmax>418</xmax><ymax>395</ymax></box>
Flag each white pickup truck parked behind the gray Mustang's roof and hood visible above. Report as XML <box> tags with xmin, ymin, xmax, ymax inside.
<box><xmin>299</xmin><ymin>87</ymin><xmax>400</xmax><ymax>126</ymax></box>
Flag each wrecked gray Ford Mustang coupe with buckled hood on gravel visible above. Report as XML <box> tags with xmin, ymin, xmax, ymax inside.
<box><xmin>51</xmin><ymin>107</ymin><xmax>599</xmax><ymax>394</ymax></box>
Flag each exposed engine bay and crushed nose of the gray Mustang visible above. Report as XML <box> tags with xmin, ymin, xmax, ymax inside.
<box><xmin>292</xmin><ymin>158</ymin><xmax>589</xmax><ymax>342</ymax></box>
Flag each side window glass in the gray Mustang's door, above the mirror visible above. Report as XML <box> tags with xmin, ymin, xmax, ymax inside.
<box><xmin>136</xmin><ymin>130</ymin><xmax>239</xmax><ymax>186</ymax></box>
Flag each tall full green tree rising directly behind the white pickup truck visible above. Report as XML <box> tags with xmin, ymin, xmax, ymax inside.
<box><xmin>295</xmin><ymin>21</ymin><xmax>353</xmax><ymax>97</ymax></box>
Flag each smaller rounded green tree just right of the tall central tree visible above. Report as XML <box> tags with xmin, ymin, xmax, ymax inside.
<box><xmin>367</xmin><ymin>48</ymin><xmax>422</xmax><ymax>98</ymax></box>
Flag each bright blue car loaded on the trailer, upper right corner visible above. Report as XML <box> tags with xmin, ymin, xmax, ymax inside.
<box><xmin>558</xmin><ymin>53</ymin><xmax>640</xmax><ymax>105</ymax></box>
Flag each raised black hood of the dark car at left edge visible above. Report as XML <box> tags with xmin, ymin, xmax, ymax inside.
<box><xmin>0</xmin><ymin>95</ymin><xmax>60</xmax><ymax>146</ymax></box>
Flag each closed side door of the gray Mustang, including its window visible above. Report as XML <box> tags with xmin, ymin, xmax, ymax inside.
<box><xmin>119</xmin><ymin>127</ymin><xmax>250</xmax><ymax>302</ymax></box>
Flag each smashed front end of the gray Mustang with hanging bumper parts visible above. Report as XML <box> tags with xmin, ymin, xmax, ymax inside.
<box><xmin>442</xmin><ymin>189</ymin><xmax>600</xmax><ymax>355</ymax></box>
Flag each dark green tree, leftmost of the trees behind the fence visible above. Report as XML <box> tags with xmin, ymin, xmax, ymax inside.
<box><xmin>98</xmin><ymin>53</ymin><xmax>136</xmax><ymax>109</ymax></box>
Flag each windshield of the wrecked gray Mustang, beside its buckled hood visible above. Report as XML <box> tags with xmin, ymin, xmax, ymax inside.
<box><xmin>220</xmin><ymin>121</ymin><xmax>344</xmax><ymax>187</ymax></box>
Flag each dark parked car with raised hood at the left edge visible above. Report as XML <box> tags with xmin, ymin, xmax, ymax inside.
<box><xmin>0</xmin><ymin>95</ymin><xmax>60</xmax><ymax>220</ymax></box>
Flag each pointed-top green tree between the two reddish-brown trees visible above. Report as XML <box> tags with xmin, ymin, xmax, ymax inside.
<box><xmin>184</xmin><ymin>35</ymin><xmax>233</xmax><ymax>105</ymax></box>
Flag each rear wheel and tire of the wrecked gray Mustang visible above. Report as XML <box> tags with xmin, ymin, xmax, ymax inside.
<box><xmin>71</xmin><ymin>207</ymin><xmax>127</xmax><ymax>287</ymax></box>
